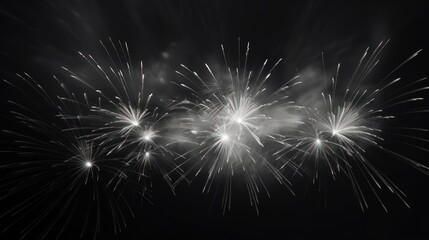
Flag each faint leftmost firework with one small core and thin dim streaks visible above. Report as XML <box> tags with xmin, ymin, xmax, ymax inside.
<box><xmin>1</xmin><ymin>74</ymin><xmax>133</xmax><ymax>239</ymax></box>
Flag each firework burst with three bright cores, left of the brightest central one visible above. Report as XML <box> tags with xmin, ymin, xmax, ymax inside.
<box><xmin>63</xmin><ymin>39</ymin><xmax>181</xmax><ymax>190</ymax></box>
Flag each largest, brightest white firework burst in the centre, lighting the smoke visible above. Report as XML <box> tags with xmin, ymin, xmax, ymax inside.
<box><xmin>167</xmin><ymin>40</ymin><xmax>300</xmax><ymax>214</ymax></box>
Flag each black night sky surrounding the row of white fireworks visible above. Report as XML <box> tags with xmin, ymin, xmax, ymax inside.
<box><xmin>0</xmin><ymin>0</ymin><xmax>429</xmax><ymax>239</ymax></box>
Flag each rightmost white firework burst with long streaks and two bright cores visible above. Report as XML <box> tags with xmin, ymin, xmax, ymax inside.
<box><xmin>276</xmin><ymin>42</ymin><xmax>429</xmax><ymax>211</ymax></box>
